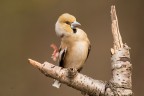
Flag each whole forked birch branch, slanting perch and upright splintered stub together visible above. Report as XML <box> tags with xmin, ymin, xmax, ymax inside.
<box><xmin>29</xmin><ymin>6</ymin><xmax>132</xmax><ymax>96</ymax></box>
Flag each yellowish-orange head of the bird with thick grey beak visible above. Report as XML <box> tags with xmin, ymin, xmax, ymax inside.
<box><xmin>55</xmin><ymin>13</ymin><xmax>81</xmax><ymax>37</ymax></box>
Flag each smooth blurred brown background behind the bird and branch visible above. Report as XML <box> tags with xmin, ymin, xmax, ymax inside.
<box><xmin>0</xmin><ymin>0</ymin><xmax>144</xmax><ymax>96</ymax></box>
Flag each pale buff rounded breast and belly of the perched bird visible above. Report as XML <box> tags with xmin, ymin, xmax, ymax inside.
<box><xmin>65</xmin><ymin>41</ymin><xmax>88</xmax><ymax>69</ymax></box>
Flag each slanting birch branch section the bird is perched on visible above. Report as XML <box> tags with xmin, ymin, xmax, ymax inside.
<box><xmin>29</xmin><ymin>59</ymin><xmax>106</xmax><ymax>96</ymax></box>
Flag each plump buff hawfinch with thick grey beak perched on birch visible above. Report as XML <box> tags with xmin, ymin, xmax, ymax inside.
<box><xmin>52</xmin><ymin>13</ymin><xmax>91</xmax><ymax>88</ymax></box>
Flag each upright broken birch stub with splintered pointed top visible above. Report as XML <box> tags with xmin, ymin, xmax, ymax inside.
<box><xmin>106</xmin><ymin>6</ymin><xmax>132</xmax><ymax>96</ymax></box>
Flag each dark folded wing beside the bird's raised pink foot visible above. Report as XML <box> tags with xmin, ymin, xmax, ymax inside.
<box><xmin>59</xmin><ymin>47</ymin><xmax>67</xmax><ymax>67</ymax></box>
